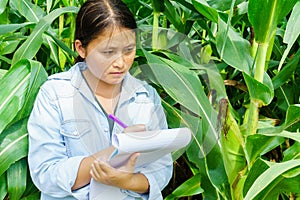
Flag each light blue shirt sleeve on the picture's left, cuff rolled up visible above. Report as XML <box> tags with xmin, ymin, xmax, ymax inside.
<box><xmin>28</xmin><ymin>86</ymin><xmax>88</xmax><ymax>199</ymax></box>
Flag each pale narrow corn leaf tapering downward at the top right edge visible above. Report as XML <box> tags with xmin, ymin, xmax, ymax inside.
<box><xmin>278</xmin><ymin>1</ymin><xmax>300</xmax><ymax>71</ymax></box>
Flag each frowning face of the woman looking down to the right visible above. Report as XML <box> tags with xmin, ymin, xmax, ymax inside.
<box><xmin>80</xmin><ymin>28</ymin><xmax>136</xmax><ymax>84</ymax></box>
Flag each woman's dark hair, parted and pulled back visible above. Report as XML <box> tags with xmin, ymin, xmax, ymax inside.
<box><xmin>75</xmin><ymin>0</ymin><xmax>137</xmax><ymax>62</ymax></box>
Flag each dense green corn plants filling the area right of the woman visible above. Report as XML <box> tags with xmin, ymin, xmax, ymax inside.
<box><xmin>130</xmin><ymin>0</ymin><xmax>300</xmax><ymax>199</ymax></box>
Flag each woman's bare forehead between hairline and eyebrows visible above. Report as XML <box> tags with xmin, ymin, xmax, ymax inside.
<box><xmin>93</xmin><ymin>28</ymin><xmax>135</xmax><ymax>47</ymax></box>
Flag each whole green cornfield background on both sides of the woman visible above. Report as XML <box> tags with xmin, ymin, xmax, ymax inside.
<box><xmin>0</xmin><ymin>0</ymin><xmax>300</xmax><ymax>200</ymax></box>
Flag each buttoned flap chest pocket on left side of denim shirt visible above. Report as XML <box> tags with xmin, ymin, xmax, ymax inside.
<box><xmin>60</xmin><ymin>119</ymin><xmax>91</xmax><ymax>157</ymax></box>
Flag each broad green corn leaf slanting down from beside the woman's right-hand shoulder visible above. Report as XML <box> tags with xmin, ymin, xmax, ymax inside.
<box><xmin>143</xmin><ymin>51</ymin><xmax>216</xmax><ymax>123</ymax></box>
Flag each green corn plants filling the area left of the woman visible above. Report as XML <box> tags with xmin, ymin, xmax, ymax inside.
<box><xmin>0</xmin><ymin>0</ymin><xmax>78</xmax><ymax>200</ymax></box>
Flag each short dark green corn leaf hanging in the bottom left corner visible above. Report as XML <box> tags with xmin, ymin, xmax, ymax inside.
<box><xmin>7</xmin><ymin>159</ymin><xmax>27</xmax><ymax>200</ymax></box>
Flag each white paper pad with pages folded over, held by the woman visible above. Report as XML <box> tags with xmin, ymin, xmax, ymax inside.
<box><xmin>90</xmin><ymin>128</ymin><xmax>192</xmax><ymax>200</ymax></box>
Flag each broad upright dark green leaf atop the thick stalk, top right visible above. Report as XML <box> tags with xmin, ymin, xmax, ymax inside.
<box><xmin>248</xmin><ymin>0</ymin><xmax>298</xmax><ymax>43</ymax></box>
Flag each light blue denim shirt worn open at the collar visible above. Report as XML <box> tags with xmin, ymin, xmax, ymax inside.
<box><xmin>28</xmin><ymin>62</ymin><xmax>173</xmax><ymax>200</ymax></box>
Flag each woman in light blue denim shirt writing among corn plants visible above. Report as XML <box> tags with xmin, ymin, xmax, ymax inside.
<box><xmin>28</xmin><ymin>0</ymin><xmax>172</xmax><ymax>200</ymax></box>
